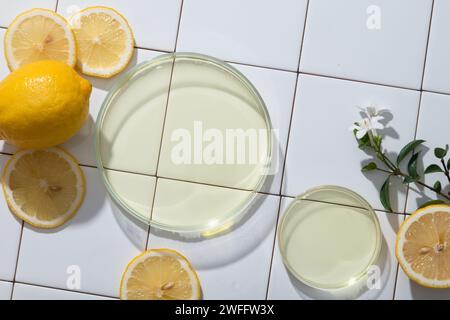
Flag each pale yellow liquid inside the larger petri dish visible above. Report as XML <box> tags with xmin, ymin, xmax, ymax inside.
<box><xmin>100</xmin><ymin>55</ymin><xmax>270</xmax><ymax>229</ymax></box>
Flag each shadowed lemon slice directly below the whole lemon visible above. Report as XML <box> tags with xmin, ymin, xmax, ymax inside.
<box><xmin>2</xmin><ymin>148</ymin><xmax>85</xmax><ymax>228</ymax></box>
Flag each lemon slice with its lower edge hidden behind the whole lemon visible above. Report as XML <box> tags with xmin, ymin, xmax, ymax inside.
<box><xmin>4</xmin><ymin>9</ymin><xmax>77</xmax><ymax>71</ymax></box>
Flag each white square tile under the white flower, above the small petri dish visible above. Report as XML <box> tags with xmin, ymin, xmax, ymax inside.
<box><xmin>283</xmin><ymin>75</ymin><xmax>419</xmax><ymax>212</ymax></box>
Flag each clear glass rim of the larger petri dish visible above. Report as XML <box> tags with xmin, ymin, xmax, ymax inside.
<box><xmin>94</xmin><ymin>52</ymin><xmax>274</xmax><ymax>235</ymax></box>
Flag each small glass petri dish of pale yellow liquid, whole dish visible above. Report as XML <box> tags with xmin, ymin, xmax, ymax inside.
<box><xmin>278</xmin><ymin>186</ymin><xmax>382</xmax><ymax>290</ymax></box>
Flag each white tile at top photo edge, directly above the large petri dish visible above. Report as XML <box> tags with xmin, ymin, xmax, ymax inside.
<box><xmin>177</xmin><ymin>0</ymin><xmax>307</xmax><ymax>71</ymax></box>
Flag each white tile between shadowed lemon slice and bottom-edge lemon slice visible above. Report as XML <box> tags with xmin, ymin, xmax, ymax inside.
<box><xmin>16</xmin><ymin>168</ymin><xmax>148</xmax><ymax>297</ymax></box>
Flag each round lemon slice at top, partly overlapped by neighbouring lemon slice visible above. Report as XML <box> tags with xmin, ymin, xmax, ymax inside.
<box><xmin>70</xmin><ymin>7</ymin><xmax>134</xmax><ymax>78</ymax></box>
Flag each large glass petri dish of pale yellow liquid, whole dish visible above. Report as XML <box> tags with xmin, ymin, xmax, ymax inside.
<box><xmin>95</xmin><ymin>53</ymin><xmax>273</xmax><ymax>236</ymax></box>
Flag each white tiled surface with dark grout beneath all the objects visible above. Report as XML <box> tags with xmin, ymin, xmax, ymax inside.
<box><xmin>0</xmin><ymin>0</ymin><xmax>450</xmax><ymax>299</ymax></box>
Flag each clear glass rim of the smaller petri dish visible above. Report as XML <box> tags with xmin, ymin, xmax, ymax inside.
<box><xmin>277</xmin><ymin>185</ymin><xmax>382</xmax><ymax>290</ymax></box>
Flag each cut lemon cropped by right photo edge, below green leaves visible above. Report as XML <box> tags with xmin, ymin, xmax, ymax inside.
<box><xmin>395</xmin><ymin>205</ymin><xmax>450</xmax><ymax>288</ymax></box>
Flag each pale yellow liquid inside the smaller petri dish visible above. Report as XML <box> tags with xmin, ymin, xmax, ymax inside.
<box><xmin>282</xmin><ymin>201</ymin><xmax>377</xmax><ymax>287</ymax></box>
